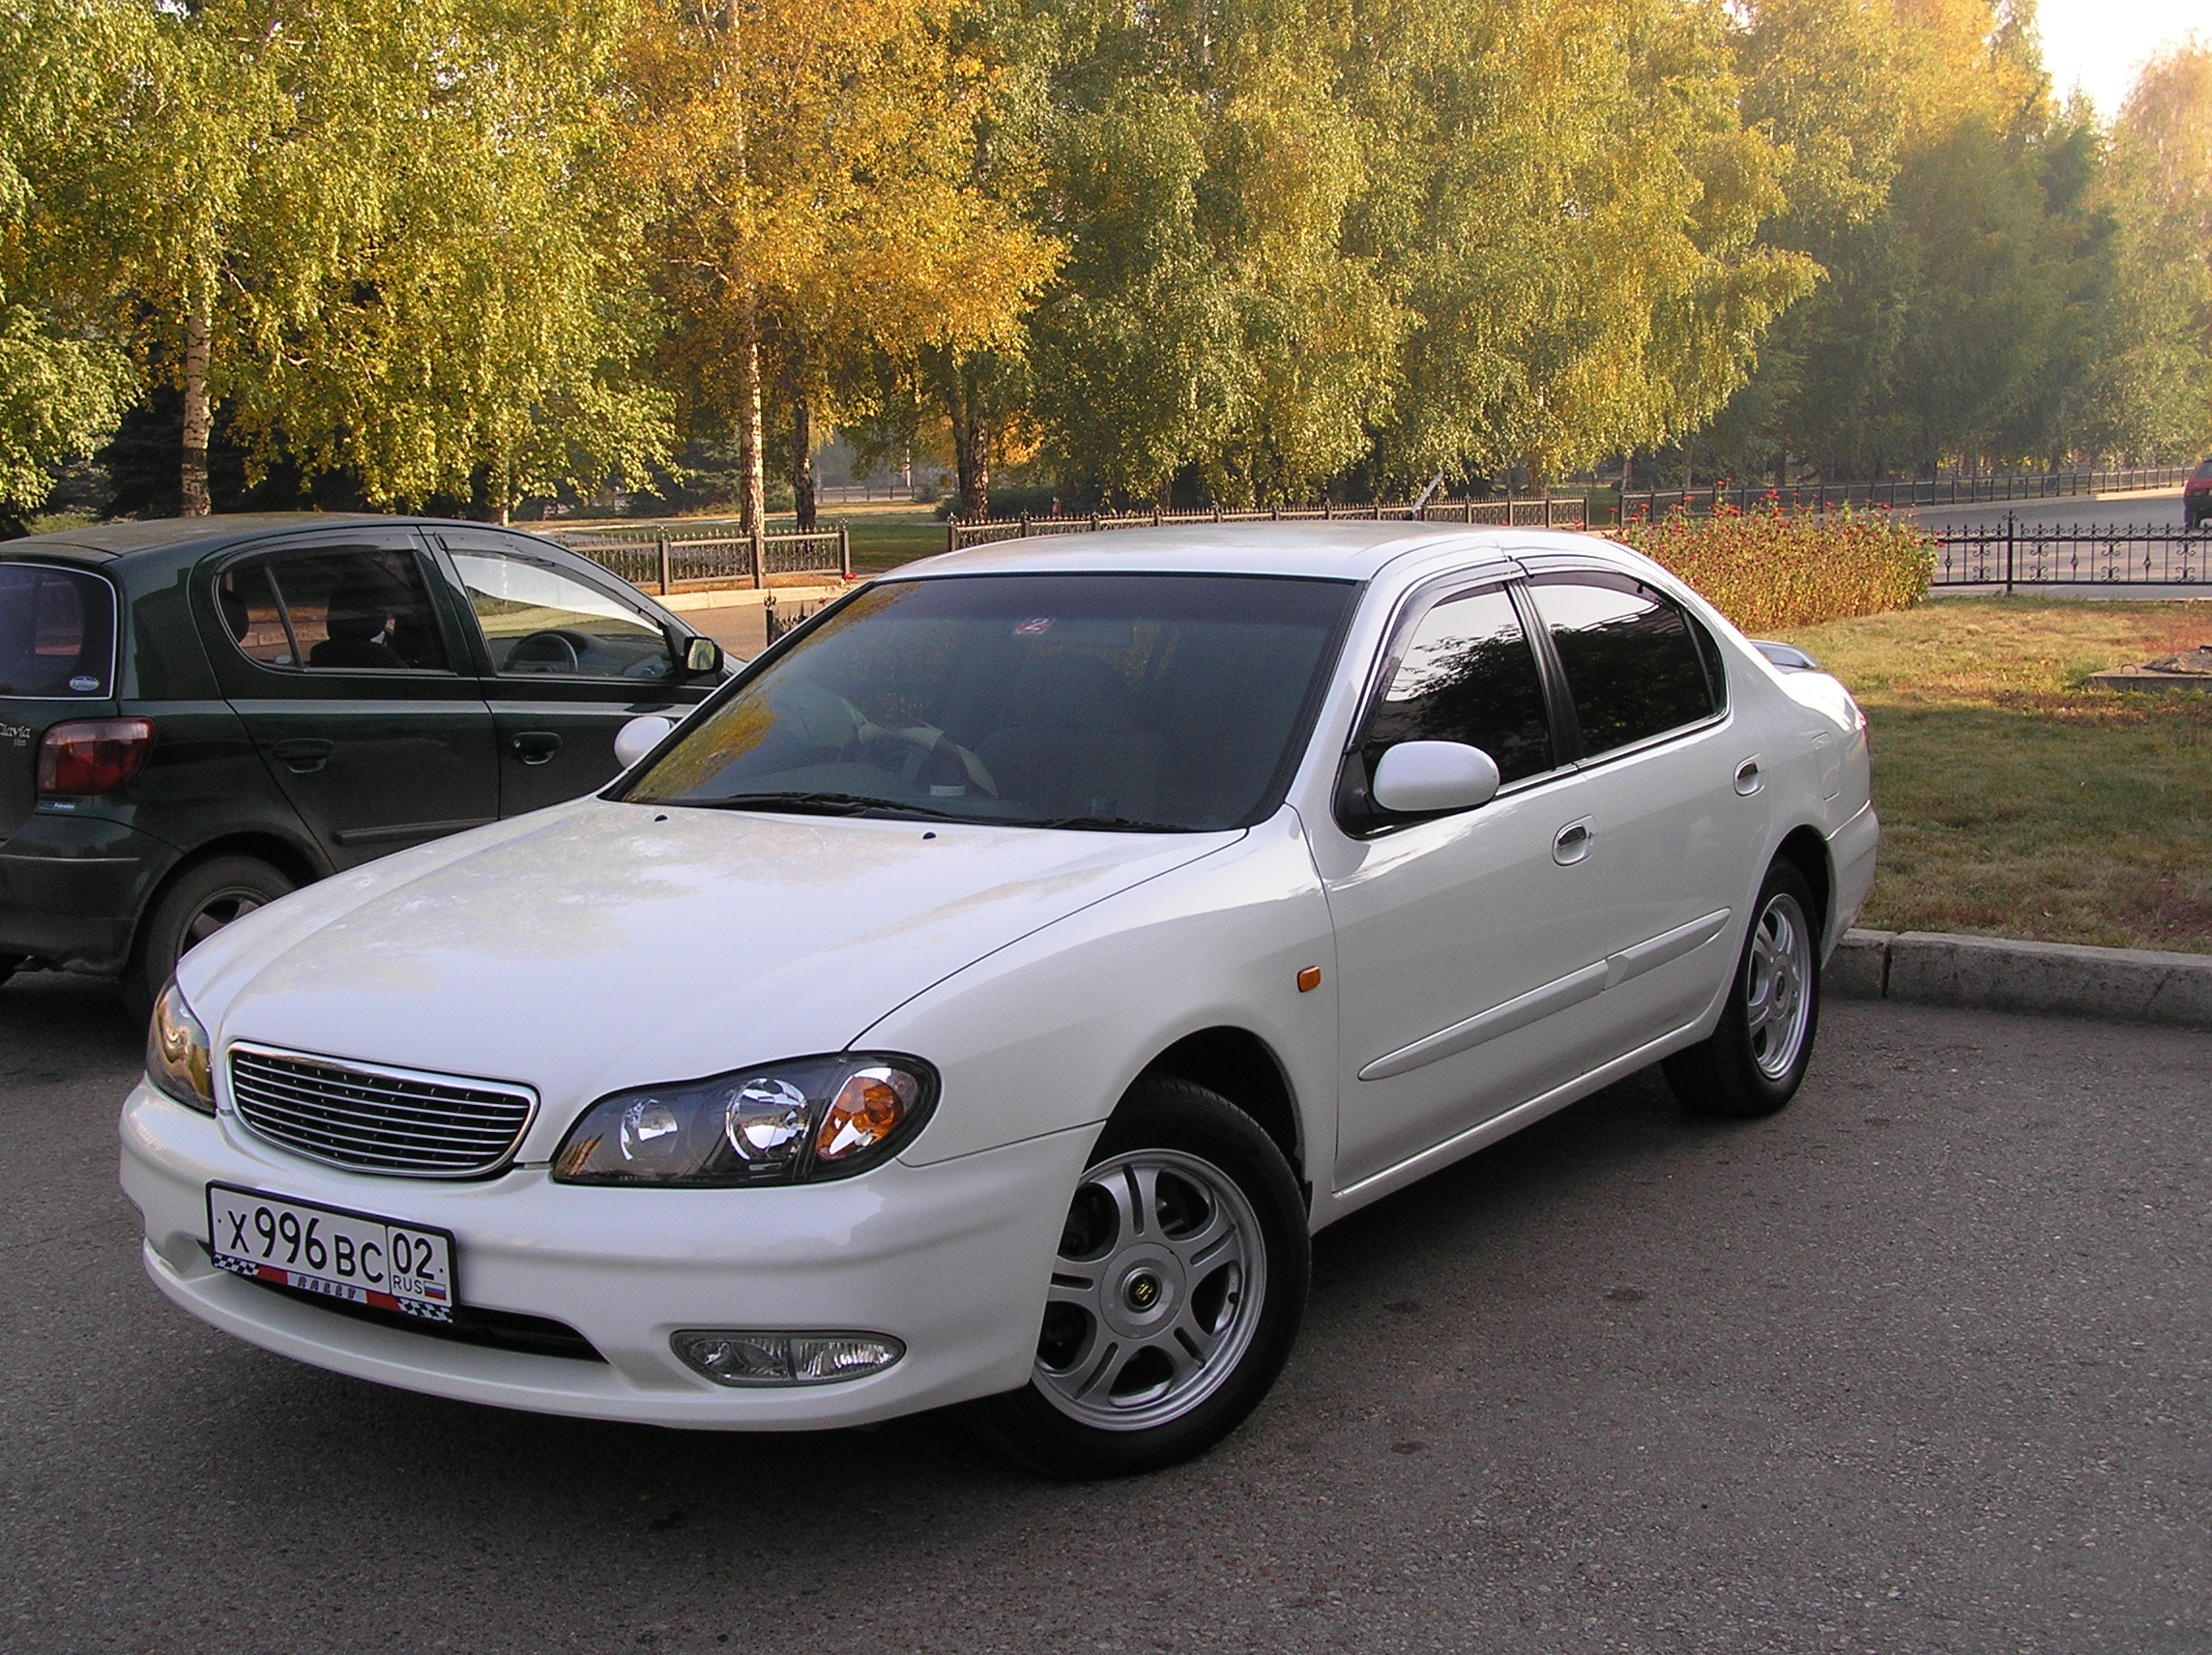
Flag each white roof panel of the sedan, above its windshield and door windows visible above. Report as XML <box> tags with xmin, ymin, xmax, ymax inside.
<box><xmin>883</xmin><ymin>518</ymin><xmax>1611</xmax><ymax>580</ymax></box>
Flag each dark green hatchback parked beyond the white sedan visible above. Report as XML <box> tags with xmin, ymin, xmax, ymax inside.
<box><xmin>0</xmin><ymin>515</ymin><xmax>723</xmax><ymax>1011</ymax></box>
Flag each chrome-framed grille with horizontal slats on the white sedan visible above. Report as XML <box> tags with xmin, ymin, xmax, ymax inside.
<box><xmin>230</xmin><ymin>1047</ymin><xmax>538</xmax><ymax>1177</ymax></box>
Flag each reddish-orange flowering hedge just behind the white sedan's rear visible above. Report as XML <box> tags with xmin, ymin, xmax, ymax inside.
<box><xmin>1615</xmin><ymin>507</ymin><xmax>1936</xmax><ymax>633</ymax></box>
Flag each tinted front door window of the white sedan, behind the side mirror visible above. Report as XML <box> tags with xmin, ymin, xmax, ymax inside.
<box><xmin>1360</xmin><ymin>587</ymin><xmax>1553</xmax><ymax>781</ymax></box>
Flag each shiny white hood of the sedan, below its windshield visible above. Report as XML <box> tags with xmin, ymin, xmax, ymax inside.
<box><xmin>177</xmin><ymin>798</ymin><xmax>1238</xmax><ymax>1152</ymax></box>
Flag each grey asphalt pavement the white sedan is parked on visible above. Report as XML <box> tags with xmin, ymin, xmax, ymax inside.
<box><xmin>0</xmin><ymin>978</ymin><xmax>2212</xmax><ymax>1655</ymax></box>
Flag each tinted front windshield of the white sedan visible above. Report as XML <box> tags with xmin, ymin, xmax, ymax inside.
<box><xmin>624</xmin><ymin>575</ymin><xmax>1356</xmax><ymax>832</ymax></box>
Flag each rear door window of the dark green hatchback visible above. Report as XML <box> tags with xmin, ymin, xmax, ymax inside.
<box><xmin>215</xmin><ymin>546</ymin><xmax>447</xmax><ymax>673</ymax></box>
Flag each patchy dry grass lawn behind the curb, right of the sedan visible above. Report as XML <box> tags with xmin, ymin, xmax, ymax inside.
<box><xmin>1790</xmin><ymin>597</ymin><xmax>2212</xmax><ymax>953</ymax></box>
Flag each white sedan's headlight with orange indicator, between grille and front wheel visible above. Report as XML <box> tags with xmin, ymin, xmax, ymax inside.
<box><xmin>553</xmin><ymin>1051</ymin><xmax>938</xmax><ymax>1188</ymax></box>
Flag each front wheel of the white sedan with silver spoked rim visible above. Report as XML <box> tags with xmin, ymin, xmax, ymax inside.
<box><xmin>969</xmin><ymin>1075</ymin><xmax>1312</xmax><ymax>1478</ymax></box>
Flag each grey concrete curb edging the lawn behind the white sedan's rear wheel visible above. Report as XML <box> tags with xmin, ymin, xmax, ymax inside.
<box><xmin>1820</xmin><ymin>932</ymin><xmax>2212</xmax><ymax>1029</ymax></box>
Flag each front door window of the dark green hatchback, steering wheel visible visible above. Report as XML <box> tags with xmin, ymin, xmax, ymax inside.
<box><xmin>447</xmin><ymin>544</ymin><xmax>675</xmax><ymax>680</ymax></box>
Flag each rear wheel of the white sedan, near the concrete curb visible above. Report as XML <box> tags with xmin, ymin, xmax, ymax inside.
<box><xmin>1664</xmin><ymin>860</ymin><xmax>1820</xmax><ymax>1118</ymax></box>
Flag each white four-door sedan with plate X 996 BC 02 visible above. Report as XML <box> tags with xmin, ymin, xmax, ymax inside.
<box><xmin>122</xmin><ymin>522</ymin><xmax>1878</xmax><ymax>1476</ymax></box>
